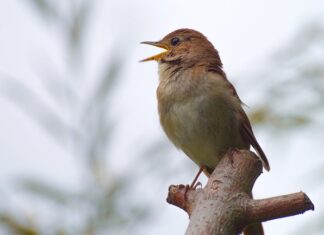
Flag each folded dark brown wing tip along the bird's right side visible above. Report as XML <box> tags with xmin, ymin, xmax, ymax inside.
<box><xmin>240</xmin><ymin>110</ymin><xmax>270</xmax><ymax>171</ymax></box>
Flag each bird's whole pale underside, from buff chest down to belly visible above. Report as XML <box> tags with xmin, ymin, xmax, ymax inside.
<box><xmin>157</xmin><ymin>66</ymin><xmax>244</xmax><ymax>169</ymax></box>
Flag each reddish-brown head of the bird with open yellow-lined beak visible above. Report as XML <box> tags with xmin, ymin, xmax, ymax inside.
<box><xmin>141</xmin><ymin>29</ymin><xmax>221</xmax><ymax>65</ymax></box>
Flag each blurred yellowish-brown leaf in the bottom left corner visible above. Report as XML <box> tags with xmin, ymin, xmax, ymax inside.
<box><xmin>0</xmin><ymin>213</ymin><xmax>40</xmax><ymax>235</ymax></box>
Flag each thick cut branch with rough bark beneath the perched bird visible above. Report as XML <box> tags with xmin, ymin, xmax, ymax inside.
<box><xmin>167</xmin><ymin>150</ymin><xmax>314</xmax><ymax>235</ymax></box>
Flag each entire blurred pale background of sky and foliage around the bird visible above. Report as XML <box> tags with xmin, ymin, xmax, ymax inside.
<box><xmin>0</xmin><ymin>0</ymin><xmax>324</xmax><ymax>235</ymax></box>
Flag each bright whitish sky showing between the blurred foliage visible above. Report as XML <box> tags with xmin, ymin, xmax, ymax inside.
<box><xmin>0</xmin><ymin>0</ymin><xmax>324</xmax><ymax>235</ymax></box>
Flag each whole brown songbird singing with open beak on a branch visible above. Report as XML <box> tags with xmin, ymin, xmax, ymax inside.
<box><xmin>142</xmin><ymin>29</ymin><xmax>270</xmax><ymax>235</ymax></box>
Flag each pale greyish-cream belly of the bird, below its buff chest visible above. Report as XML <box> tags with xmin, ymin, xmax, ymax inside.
<box><xmin>160</xmin><ymin>93</ymin><xmax>244</xmax><ymax>169</ymax></box>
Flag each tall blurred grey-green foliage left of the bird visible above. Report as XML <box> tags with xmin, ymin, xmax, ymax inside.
<box><xmin>0</xmin><ymin>0</ymin><xmax>148</xmax><ymax>235</ymax></box>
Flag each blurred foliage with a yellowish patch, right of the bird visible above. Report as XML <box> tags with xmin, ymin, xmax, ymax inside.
<box><xmin>249</xmin><ymin>22</ymin><xmax>324</xmax><ymax>131</ymax></box>
